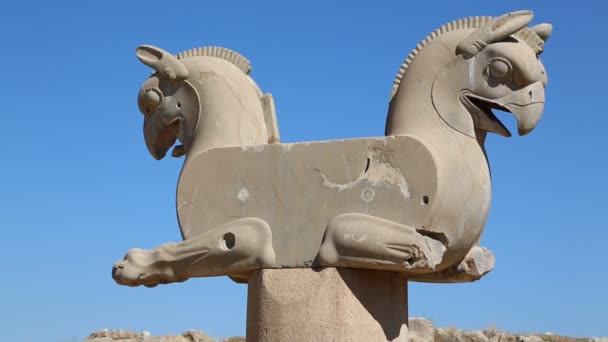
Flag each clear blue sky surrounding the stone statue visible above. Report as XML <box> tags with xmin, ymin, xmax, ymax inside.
<box><xmin>0</xmin><ymin>0</ymin><xmax>608</xmax><ymax>341</ymax></box>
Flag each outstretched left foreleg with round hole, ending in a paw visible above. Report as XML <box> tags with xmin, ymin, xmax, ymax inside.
<box><xmin>112</xmin><ymin>217</ymin><xmax>275</xmax><ymax>287</ymax></box>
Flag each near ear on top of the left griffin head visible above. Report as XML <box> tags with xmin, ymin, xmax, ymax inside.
<box><xmin>135</xmin><ymin>45</ymin><xmax>188</xmax><ymax>80</ymax></box>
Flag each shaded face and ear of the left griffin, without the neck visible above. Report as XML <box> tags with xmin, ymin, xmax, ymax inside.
<box><xmin>136</xmin><ymin>45</ymin><xmax>200</xmax><ymax>160</ymax></box>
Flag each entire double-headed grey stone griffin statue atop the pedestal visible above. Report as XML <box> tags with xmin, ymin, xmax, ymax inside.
<box><xmin>112</xmin><ymin>11</ymin><xmax>551</xmax><ymax>287</ymax></box>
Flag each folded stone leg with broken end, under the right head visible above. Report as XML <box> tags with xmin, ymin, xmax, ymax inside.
<box><xmin>319</xmin><ymin>214</ymin><xmax>446</xmax><ymax>274</ymax></box>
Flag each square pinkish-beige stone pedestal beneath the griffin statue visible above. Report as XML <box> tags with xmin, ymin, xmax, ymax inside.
<box><xmin>247</xmin><ymin>268</ymin><xmax>408</xmax><ymax>342</ymax></box>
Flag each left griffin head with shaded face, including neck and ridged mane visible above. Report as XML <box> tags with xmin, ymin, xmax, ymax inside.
<box><xmin>136</xmin><ymin>45</ymin><xmax>264</xmax><ymax>159</ymax></box>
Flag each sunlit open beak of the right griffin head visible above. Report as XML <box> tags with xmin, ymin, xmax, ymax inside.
<box><xmin>463</xmin><ymin>82</ymin><xmax>545</xmax><ymax>137</ymax></box>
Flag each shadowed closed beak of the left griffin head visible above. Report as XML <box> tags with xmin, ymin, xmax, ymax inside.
<box><xmin>144</xmin><ymin>113</ymin><xmax>181</xmax><ymax>160</ymax></box>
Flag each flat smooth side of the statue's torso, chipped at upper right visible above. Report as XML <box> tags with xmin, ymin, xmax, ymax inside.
<box><xmin>177</xmin><ymin>137</ymin><xmax>440</xmax><ymax>267</ymax></box>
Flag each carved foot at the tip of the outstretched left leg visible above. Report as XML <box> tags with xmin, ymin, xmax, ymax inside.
<box><xmin>112</xmin><ymin>248</ymin><xmax>185</xmax><ymax>287</ymax></box>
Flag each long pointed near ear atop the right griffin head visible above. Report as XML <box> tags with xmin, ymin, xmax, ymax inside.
<box><xmin>456</xmin><ymin>11</ymin><xmax>533</xmax><ymax>58</ymax></box>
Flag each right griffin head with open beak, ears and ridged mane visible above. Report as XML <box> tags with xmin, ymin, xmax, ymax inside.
<box><xmin>393</xmin><ymin>11</ymin><xmax>551</xmax><ymax>139</ymax></box>
